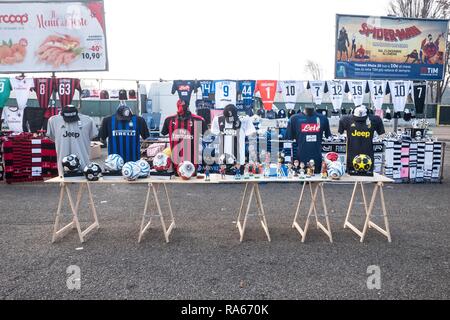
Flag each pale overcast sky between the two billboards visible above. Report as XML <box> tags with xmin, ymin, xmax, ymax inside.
<box><xmin>96</xmin><ymin>0</ymin><xmax>389</xmax><ymax>80</ymax></box>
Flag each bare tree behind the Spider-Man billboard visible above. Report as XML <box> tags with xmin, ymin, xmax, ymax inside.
<box><xmin>388</xmin><ymin>0</ymin><xmax>450</xmax><ymax>103</ymax></box>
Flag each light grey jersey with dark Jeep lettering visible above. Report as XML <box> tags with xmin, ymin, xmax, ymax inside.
<box><xmin>47</xmin><ymin>114</ymin><xmax>97</xmax><ymax>176</ymax></box>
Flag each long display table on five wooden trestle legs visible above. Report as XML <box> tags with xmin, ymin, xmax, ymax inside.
<box><xmin>46</xmin><ymin>174</ymin><xmax>393</xmax><ymax>243</ymax></box>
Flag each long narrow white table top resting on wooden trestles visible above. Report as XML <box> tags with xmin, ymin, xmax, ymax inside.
<box><xmin>46</xmin><ymin>173</ymin><xmax>394</xmax><ymax>184</ymax></box>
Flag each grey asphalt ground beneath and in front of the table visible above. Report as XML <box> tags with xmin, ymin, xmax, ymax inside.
<box><xmin>0</xmin><ymin>145</ymin><xmax>450</xmax><ymax>300</ymax></box>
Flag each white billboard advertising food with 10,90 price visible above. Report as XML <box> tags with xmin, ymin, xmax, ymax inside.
<box><xmin>0</xmin><ymin>1</ymin><xmax>108</xmax><ymax>73</ymax></box>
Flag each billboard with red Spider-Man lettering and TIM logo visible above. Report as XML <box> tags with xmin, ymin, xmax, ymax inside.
<box><xmin>335</xmin><ymin>15</ymin><xmax>449</xmax><ymax>80</ymax></box>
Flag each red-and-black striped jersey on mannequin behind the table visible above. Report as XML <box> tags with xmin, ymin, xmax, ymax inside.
<box><xmin>161</xmin><ymin>113</ymin><xmax>208</xmax><ymax>168</ymax></box>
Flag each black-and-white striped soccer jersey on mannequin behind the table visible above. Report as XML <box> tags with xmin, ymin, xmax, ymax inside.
<box><xmin>211</xmin><ymin>116</ymin><xmax>256</xmax><ymax>165</ymax></box>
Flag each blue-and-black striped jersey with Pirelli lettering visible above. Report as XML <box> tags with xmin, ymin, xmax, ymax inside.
<box><xmin>99</xmin><ymin>115</ymin><xmax>150</xmax><ymax>162</ymax></box>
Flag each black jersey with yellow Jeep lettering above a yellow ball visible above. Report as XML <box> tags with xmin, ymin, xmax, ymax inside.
<box><xmin>339</xmin><ymin>115</ymin><xmax>385</xmax><ymax>175</ymax></box>
